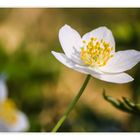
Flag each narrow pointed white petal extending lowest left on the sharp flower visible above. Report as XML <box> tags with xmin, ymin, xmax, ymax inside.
<box><xmin>52</xmin><ymin>51</ymin><xmax>102</xmax><ymax>74</ymax></box>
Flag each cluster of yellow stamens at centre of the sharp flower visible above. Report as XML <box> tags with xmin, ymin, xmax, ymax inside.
<box><xmin>80</xmin><ymin>37</ymin><xmax>113</xmax><ymax>67</ymax></box>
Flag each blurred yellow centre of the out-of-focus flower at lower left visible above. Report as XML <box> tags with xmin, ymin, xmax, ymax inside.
<box><xmin>0</xmin><ymin>99</ymin><xmax>17</xmax><ymax>125</ymax></box>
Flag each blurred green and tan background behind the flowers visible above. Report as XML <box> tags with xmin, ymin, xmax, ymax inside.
<box><xmin>0</xmin><ymin>8</ymin><xmax>140</xmax><ymax>132</ymax></box>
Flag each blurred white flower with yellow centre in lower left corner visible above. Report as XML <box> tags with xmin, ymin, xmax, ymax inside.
<box><xmin>0</xmin><ymin>78</ymin><xmax>29</xmax><ymax>132</ymax></box>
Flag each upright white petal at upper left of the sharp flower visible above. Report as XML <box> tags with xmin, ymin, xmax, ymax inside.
<box><xmin>59</xmin><ymin>25</ymin><xmax>82</xmax><ymax>58</ymax></box>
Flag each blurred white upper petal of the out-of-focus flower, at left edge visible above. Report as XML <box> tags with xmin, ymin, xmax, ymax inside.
<box><xmin>0</xmin><ymin>78</ymin><xmax>8</xmax><ymax>101</ymax></box>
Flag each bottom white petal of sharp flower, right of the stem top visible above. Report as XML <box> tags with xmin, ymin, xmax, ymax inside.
<box><xmin>92</xmin><ymin>73</ymin><xmax>134</xmax><ymax>84</ymax></box>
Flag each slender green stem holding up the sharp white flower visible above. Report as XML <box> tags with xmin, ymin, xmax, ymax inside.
<box><xmin>52</xmin><ymin>75</ymin><xmax>90</xmax><ymax>132</ymax></box>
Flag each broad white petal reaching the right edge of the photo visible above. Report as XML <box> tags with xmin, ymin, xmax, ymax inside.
<box><xmin>100</xmin><ymin>50</ymin><xmax>140</xmax><ymax>73</ymax></box>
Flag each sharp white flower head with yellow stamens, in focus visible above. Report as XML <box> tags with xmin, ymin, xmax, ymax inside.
<box><xmin>52</xmin><ymin>25</ymin><xmax>140</xmax><ymax>83</ymax></box>
